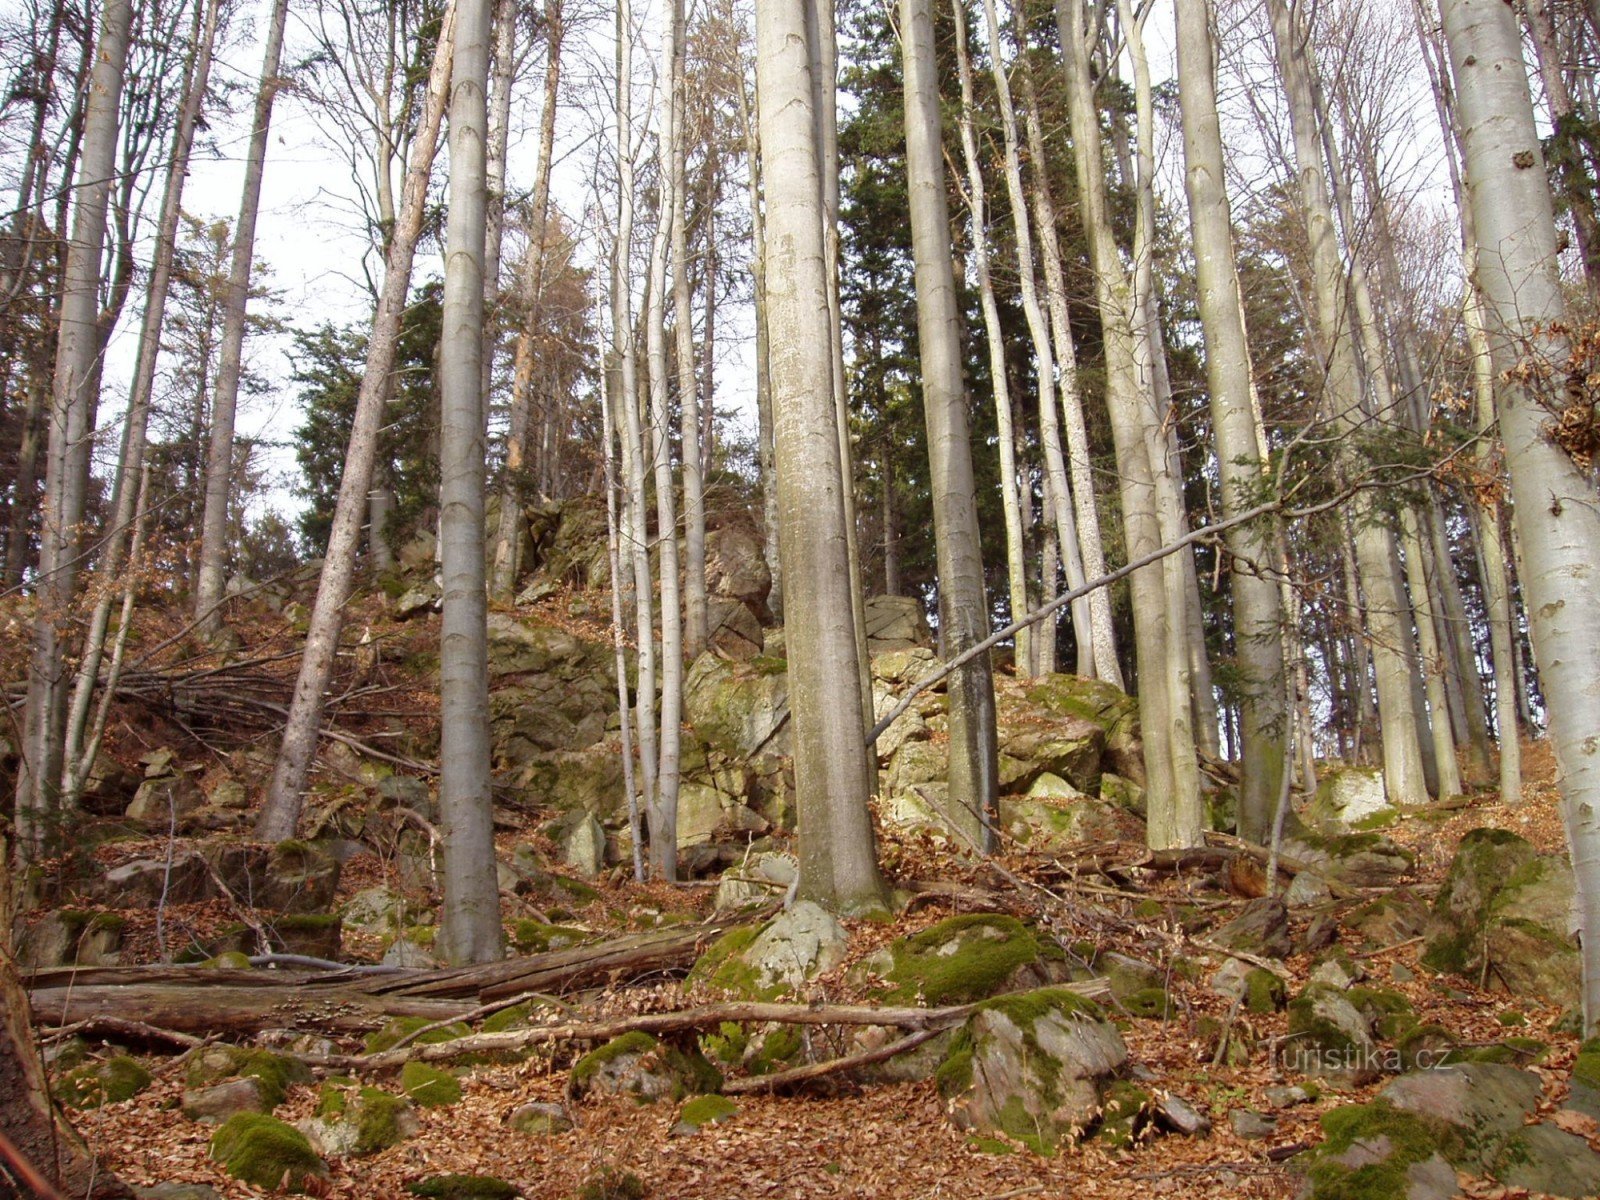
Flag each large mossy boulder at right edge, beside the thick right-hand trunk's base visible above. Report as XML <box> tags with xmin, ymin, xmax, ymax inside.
<box><xmin>1422</xmin><ymin>829</ymin><xmax>1581</xmax><ymax>1006</ymax></box>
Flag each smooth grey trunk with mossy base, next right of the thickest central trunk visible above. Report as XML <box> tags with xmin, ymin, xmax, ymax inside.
<box><xmin>902</xmin><ymin>0</ymin><xmax>998</xmax><ymax>853</ymax></box>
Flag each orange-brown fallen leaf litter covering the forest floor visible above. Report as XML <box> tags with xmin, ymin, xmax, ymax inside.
<box><xmin>9</xmin><ymin>598</ymin><xmax>1600</xmax><ymax>1200</ymax></box>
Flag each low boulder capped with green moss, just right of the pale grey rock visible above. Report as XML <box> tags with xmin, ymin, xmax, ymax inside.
<box><xmin>858</xmin><ymin>912</ymin><xmax>1050</xmax><ymax>1008</ymax></box>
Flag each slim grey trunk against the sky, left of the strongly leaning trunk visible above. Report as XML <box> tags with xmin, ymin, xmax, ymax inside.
<box><xmin>195</xmin><ymin>0</ymin><xmax>290</xmax><ymax>632</ymax></box>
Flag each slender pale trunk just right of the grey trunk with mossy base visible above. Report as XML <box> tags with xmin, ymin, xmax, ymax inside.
<box><xmin>947</xmin><ymin>0</ymin><xmax>1040</xmax><ymax>672</ymax></box>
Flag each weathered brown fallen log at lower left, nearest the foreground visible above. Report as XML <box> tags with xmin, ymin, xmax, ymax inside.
<box><xmin>29</xmin><ymin>973</ymin><xmax>472</xmax><ymax>1037</ymax></box>
